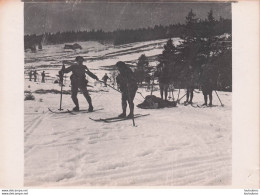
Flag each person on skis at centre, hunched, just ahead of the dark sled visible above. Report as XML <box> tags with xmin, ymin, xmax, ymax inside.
<box><xmin>116</xmin><ymin>61</ymin><xmax>138</xmax><ymax>118</ymax></box>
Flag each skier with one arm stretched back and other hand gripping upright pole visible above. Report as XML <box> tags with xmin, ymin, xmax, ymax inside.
<box><xmin>59</xmin><ymin>56</ymin><xmax>99</xmax><ymax>112</ymax></box>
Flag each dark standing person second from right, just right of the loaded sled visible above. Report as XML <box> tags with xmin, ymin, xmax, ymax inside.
<box><xmin>184</xmin><ymin>65</ymin><xmax>194</xmax><ymax>104</ymax></box>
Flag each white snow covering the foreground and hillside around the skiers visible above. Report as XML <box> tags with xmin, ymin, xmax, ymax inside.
<box><xmin>24</xmin><ymin>40</ymin><xmax>232</xmax><ymax>186</ymax></box>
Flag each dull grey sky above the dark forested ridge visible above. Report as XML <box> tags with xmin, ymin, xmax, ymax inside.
<box><xmin>24</xmin><ymin>3</ymin><xmax>231</xmax><ymax>34</ymax></box>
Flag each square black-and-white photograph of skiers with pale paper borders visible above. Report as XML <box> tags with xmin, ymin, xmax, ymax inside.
<box><xmin>24</xmin><ymin>1</ymin><xmax>233</xmax><ymax>187</ymax></box>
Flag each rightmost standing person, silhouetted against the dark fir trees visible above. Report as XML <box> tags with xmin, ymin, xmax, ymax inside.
<box><xmin>200</xmin><ymin>64</ymin><xmax>214</xmax><ymax>106</ymax></box>
